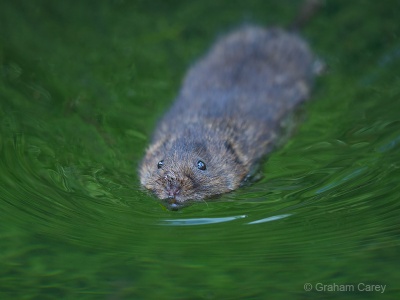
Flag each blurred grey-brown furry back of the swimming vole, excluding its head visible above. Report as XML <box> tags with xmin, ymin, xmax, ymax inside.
<box><xmin>154</xmin><ymin>26</ymin><xmax>313</xmax><ymax>165</ymax></box>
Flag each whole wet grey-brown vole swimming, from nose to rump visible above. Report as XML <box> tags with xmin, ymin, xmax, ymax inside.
<box><xmin>140</xmin><ymin>26</ymin><xmax>313</xmax><ymax>206</ymax></box>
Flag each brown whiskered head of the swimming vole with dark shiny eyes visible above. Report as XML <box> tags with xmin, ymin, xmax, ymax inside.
<box><xmin>140</xmin><ymin>138</ymin><xmax>247</xmax><ymax>210</ymax></box>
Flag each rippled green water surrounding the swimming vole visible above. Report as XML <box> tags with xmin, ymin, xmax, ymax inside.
<box><xmin>0</xmin><ymin>0</ymin><xmax>400</xmax><ymax>299</ymax></box>
